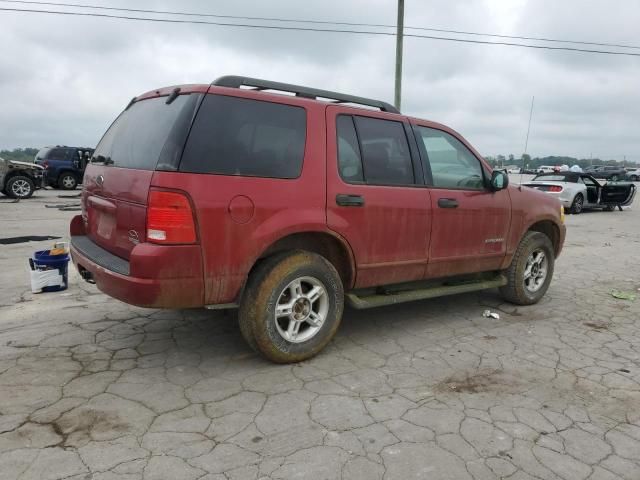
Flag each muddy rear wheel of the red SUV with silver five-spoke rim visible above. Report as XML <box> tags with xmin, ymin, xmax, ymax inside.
<box><xmin>239</xmin><ymin>251</ymin><xmax>344</xmax><ymax>363</ymax></box>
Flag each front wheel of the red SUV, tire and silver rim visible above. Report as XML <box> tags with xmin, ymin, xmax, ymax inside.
<box><xmin>500</xmin><ymin>232</ymin><xmax>555</xmax><ymax>305</ymax></box>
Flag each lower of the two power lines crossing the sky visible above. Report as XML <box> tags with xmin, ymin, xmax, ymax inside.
<box><xmin>0</xmin><ymin>6</ymin><xmax>640</xmax><ymax>57</ymax></box>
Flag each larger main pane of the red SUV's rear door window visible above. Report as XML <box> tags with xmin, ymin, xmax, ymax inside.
<box><xmin>355</xmin><ymin>117</ymin><xmax>414</xmax><ymax>185</ymax></box>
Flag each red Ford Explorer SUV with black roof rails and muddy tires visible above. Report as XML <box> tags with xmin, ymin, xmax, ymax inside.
<box><xmin>71</xmin><ymin>76</ymin><xmax>565</xmax><ymax>362</ymax></box>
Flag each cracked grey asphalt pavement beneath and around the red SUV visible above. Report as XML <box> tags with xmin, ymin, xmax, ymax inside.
<box><xmin>0</xmin><ymin>190</ymin><xmax>640</xmax><ymax>480</ymax></box>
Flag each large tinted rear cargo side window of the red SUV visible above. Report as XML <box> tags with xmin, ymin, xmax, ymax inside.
<box><xmin>180</xmin><ymin>95</ymin><xmax>307</xmax><ymax>178</ymax></box>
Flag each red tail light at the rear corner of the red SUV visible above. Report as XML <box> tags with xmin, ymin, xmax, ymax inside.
<box><xmin>147</xmin><ymin>190</ymin><xmax>196</xmax><ymax>244</ymax></box>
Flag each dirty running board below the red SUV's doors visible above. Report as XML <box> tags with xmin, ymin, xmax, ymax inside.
<box><xmin>345</xmin><ymin>275</ymin><xmax>507</xmax><ymax>310</ymax></box>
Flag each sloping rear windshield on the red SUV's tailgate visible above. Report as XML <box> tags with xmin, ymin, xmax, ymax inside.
<box><xmin>92</xmin><ymin>94</ymin><xmax>199</xmax><ymax>170</ymax></box>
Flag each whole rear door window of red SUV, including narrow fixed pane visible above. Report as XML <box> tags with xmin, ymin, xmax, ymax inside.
<box><xmin>336</xmin><ymin>115</ymin><xmax>415</xmax><ymax>185</ymax></box>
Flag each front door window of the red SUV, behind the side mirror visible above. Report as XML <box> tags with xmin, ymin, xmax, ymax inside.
<box><xmin>416</xmin><ymin>127</ymin><xmax>484</xmax><ymax>190</ymax></box>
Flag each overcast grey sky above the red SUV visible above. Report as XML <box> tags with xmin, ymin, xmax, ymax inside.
<box><xmin>0</xmin><ymin>0</ymin><xmax>640</xmax><ymax>161</ymax></box>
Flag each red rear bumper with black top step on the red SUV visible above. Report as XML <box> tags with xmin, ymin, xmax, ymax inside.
<box><xmin>71</xmin><ymin>231</ymin><xmax>204</xmax><ymax>308</ymax></box>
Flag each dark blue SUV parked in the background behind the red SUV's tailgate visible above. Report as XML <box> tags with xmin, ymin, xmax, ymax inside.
<box><xmin>35</xmin><ymin>145</ymin><xmax>93</xmax><ymax>190</ymax></box>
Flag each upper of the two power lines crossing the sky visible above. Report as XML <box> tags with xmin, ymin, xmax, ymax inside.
<box><xmin>0</xmin><ymin>0</ymin><xmax>640</xmax><ymax>50</ymax></box>
